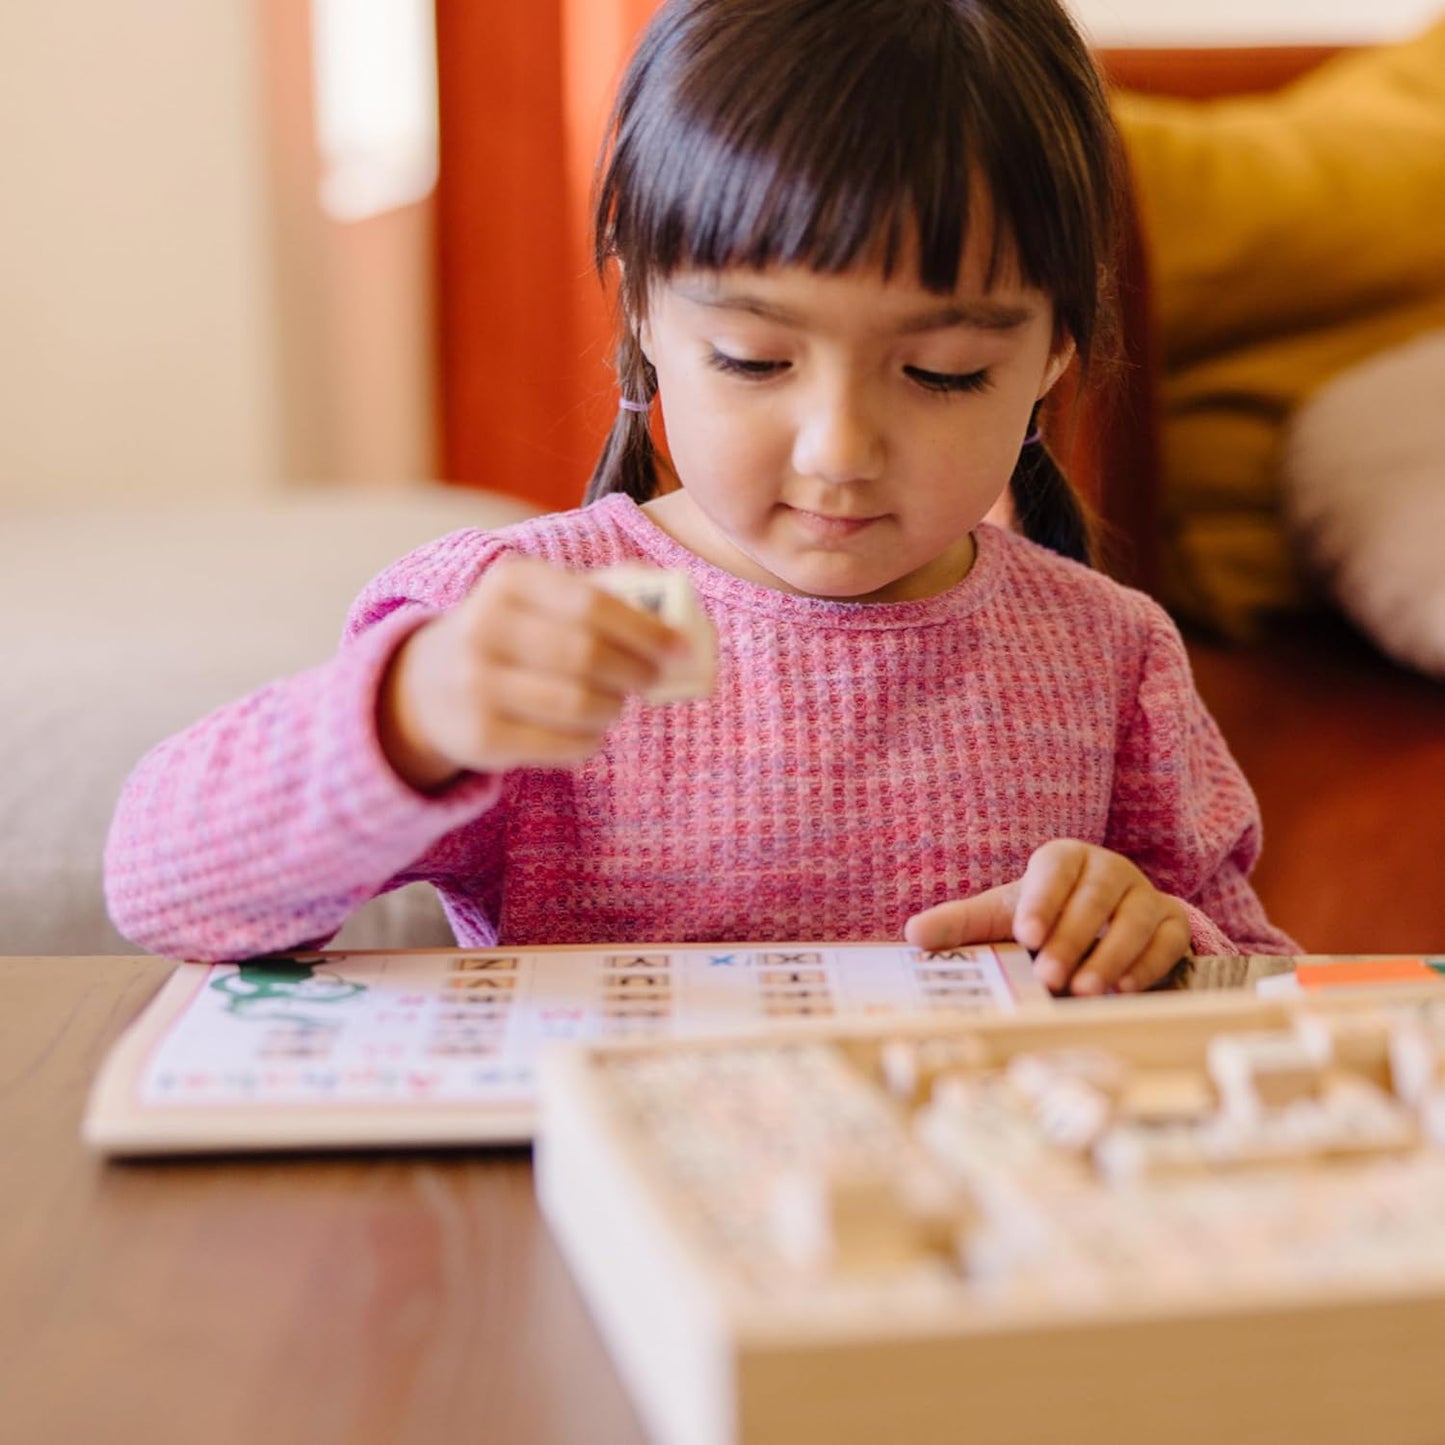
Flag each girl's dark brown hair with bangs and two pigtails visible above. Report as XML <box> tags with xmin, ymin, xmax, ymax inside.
<box><xmin>587</xmin><ymin>0</ymin><xmax>1120</xmax><ymax>561</ymax></box>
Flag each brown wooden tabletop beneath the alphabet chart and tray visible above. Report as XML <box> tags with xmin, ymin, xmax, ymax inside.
<box><xmin>0</xmin><ymin>958</ymin><xmax>643</xmax><ymax>1445</ymax></box>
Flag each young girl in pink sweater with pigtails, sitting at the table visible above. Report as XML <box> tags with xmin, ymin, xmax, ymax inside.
<box><xmin>107</xmin><ymin>0</ymin><xmax>1292</xmax><ymax>993</ymax></box>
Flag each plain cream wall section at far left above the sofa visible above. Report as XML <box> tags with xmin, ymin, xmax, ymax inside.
<box><xmin>0</xmin><ymin>0</ymin><xmax>280</xmax><ymax>504</ymax></box>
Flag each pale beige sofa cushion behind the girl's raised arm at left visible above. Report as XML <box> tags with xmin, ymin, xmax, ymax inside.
<box><xmin>0</xmin><ymin>486</ymin><xmax>530</xmax><ymax>955</ymax></box>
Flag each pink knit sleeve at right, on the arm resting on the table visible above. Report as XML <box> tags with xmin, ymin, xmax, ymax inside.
<box><xmin>1104</xmin><ymin>605</ymin><xmax>1299</xmax><ymax>954</ymax></box>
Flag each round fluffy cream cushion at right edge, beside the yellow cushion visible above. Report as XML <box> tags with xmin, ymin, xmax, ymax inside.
<box><xmin>1283</xmin><ymin>331</ymin><xmax>1445</xmax><ymax>679</ymax></box>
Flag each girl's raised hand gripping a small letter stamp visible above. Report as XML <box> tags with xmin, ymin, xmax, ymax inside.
<box><xmin>377</xmin><ymin>556</ymin><xmax>689</xmax><ymax>792</ymax></box>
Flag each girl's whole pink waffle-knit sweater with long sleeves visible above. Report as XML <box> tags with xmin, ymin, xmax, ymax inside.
<box><xmin>105</xmin><ymin>497</ymin><xmax>1293</xmax><ymax>959</ymax></box>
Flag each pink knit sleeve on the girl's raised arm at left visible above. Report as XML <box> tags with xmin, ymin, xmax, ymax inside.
<box><xmin>105</xmin><ymin>535</ymin><xmax>501</xmax><ymax>961</ymax></box>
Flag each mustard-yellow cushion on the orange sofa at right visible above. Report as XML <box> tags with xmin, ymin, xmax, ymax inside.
<box><xmin>1116</xmin><ymin>22</ymin><xmax>1445</xmax><ymax>633</ymax></box>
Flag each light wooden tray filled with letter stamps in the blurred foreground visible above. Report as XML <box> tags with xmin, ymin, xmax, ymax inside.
<box><xmin>536</xmin><ymin>987</ymin><xmax>1445</xmax><ymax>1445</ymax></box>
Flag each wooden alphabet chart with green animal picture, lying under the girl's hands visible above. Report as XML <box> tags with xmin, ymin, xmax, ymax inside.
<box><xmin>85</xmin><ymin>944</ymin><xmax>1049</xmax><ymax>1153</ymax></box>
